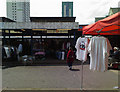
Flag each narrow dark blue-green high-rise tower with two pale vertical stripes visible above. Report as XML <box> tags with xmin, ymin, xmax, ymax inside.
<box><xmin>62</xmin><ymin>2</ymin><xmax>73</xmax><ymax>17</ymax></box>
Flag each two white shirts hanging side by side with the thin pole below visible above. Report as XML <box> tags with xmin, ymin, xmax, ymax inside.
<box><xmin>75</xmin><ymin>36</ymin><xmax>112</xmax><ymax>89</ymax></box>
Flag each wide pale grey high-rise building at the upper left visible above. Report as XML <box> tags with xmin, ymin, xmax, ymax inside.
<box><xmin>7</xmin><ymin>0</ymin><xmax>30</xmax><ymax>22</ymax></box>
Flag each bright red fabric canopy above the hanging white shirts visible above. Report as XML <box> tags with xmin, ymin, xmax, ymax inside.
<box><xmin>83</xmin><ymin>12</ymin><xmax>120</xmax><ymax>35</ymax></box>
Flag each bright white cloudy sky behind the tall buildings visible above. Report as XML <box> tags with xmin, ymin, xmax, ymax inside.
<box><xmin>0</xmin><ymin>0</ymin><xmax>120</xmax><ymax>25</ymax></box>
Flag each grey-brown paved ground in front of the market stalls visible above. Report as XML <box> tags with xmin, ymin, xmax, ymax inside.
<box><xmin>2</xmin><ymin>60</ymin><xmax>118</xmax><ymax>90</ymax></box>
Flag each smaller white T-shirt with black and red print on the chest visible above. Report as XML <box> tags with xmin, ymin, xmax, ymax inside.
<box><xmin>75</xmin><ymin>37</ymin><xmax>89</xmax><ymax>61</ymax></box>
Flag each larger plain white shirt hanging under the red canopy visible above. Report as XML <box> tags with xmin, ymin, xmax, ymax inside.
<box><xmin>88</xmin><ymin>36</ymin><xmax>112</xmax><ymax>72</ymax></box>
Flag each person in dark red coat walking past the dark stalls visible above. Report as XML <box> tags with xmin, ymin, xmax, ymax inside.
<box><xmin>67</xmin><ymin>47</ymin><xmax>74</xmax><ymax>70</ymax></box>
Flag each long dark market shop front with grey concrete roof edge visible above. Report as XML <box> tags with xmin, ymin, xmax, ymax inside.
<box><xmin>1</xmin><ymin>18</ymin><xmax>79</xmax><ymax>63</ymax></box>
